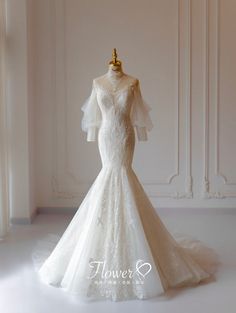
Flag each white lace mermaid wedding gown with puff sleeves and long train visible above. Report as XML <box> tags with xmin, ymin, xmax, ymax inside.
<box><xmin>34</xmin><ymin>74</ymin><xmax>218</xmax><ymax>301</ymax></box>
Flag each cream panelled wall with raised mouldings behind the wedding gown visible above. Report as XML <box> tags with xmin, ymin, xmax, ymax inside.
<box><xmin>6</xmin><ymin>0</ymin><xmax>236</xmax><ymax>217</ymax></box>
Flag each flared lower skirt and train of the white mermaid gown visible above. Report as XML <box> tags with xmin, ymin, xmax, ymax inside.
<box><xmin>32</xmin><ymin>168</ymin><xmax>217</xmax><ymax>301</ymax></box>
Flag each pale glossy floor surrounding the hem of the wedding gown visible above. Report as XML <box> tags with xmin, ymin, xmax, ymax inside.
<box><xmin>0</xmin><ymin>210</ymin><xmax>236</xmax><ymax>313</ymax></box>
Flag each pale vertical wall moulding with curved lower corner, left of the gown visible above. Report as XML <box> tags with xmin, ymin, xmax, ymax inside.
<box><xmin>51</xmin><ymin>0</ymin><xmax>81</xmax><ymax>199</ymax></box>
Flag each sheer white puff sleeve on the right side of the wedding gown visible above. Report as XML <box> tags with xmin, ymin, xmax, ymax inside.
<box><xmin>130</xmin><ymin>79</ymin><xmax>153</xmax><ymax>141</ymax></box>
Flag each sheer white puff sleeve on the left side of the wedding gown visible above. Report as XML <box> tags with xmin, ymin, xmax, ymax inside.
<box><xmin>81</xmin><ymin>80</ymin><xmax>102</xmax><ymax>141</ymax></box>
